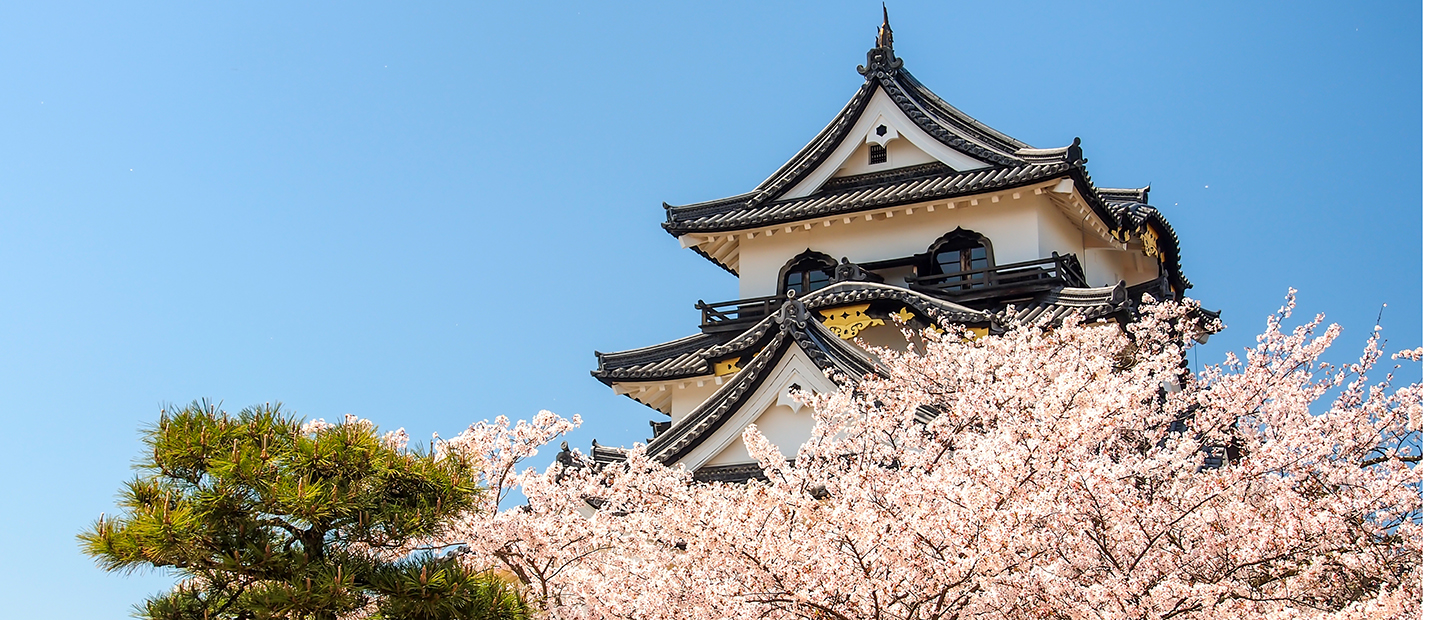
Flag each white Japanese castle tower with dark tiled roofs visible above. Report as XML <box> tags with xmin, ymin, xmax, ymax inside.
<box><xmin>590</xmin><ymin>12</ymin><xmax>1191</xmax><ymax>480</ymax></box>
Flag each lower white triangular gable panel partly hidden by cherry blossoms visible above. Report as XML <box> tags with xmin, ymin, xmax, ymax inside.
<box><xmin>678</xmin><ymin>342</ymin><xmax>837</xmax><ymax>472</ymax></box>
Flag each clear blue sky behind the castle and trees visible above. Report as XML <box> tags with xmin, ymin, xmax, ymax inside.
<box><xmin>0</xmin><ymin>0</ymin><xmax>1421</xmax><ymax>619</ymax></box>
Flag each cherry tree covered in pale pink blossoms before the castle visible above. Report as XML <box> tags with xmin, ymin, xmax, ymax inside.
<box><xmin>432</xmin><ymin>292</ymin><xmax>1423</xmax><ymax>620</ymax></box>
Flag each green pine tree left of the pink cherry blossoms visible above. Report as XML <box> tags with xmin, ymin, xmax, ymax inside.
<box><xmin>79</xmin><ymin>401</ymin><xmax>527</xmax><ymax>620</ymax></box>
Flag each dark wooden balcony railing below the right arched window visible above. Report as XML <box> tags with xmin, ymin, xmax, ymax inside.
<box><xmin>906</xmin><ymin>252</ymin><xmax>1087</xmax><ymax>301</ymax></box>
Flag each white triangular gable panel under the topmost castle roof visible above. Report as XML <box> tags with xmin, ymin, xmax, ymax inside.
<box><xmin>780</xmin><ymin>89</ymin><xmax>989</xmax><ymax>200</ymax></box>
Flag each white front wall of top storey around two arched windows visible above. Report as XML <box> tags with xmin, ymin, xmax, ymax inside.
<box><xmin>739</xmin><ymin>195</ymin><xmax>1053</xmax><ymax>298</ymax></box>
